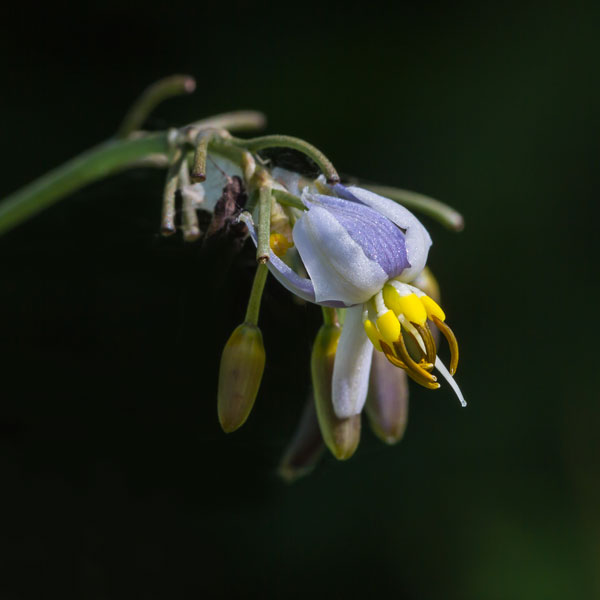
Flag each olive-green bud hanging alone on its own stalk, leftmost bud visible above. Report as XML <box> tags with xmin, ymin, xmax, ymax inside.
<box><xmin>217</xmin><ymin>323</ymin><xmax>265</xmax><ymax>433</ymax></box>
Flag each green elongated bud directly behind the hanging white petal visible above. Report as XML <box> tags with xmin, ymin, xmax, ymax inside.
<box><xmin>311</xmin><ymin>324</ymin><xmax>360</xmax><ymax>460</ymax></box>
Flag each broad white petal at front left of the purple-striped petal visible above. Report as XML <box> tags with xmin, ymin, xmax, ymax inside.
<box><xmin>293</xmin><ymin>206</ymin><xmax>388</xmax><ymax>306</ymax></box>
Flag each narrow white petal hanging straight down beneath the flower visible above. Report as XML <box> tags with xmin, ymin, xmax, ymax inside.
<box><xmin>331</xmin><ymin>306</ymin><xmax>373</xmax><ymax>419</ymax></box>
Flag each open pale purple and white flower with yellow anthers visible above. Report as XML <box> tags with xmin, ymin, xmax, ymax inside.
<box><xmin>242</xmin><ymin>184</ymin><xmax>466</xmax><ymax>418</ymax></box>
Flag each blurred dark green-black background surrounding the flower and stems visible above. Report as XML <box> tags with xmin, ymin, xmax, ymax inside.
<box><xmin>0</xmin><ymin>1</ymin><xmax>600</xmax><ymax>600</ymax></box>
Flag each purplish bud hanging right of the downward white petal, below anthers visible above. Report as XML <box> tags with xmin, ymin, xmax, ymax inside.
<box><xmin>365</xmin><ymin>352</ymin><xmax>408</xmax><ymax>444</ymax></box>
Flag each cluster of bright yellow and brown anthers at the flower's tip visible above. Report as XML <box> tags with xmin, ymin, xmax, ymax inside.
<box><xmin>363</xmin><ymin>280</ymin><xmax>458</xmax><ymax>389</ymax></box>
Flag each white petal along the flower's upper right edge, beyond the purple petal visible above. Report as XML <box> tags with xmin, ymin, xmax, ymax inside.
<box><xmin>347</xmin><ymin>186</ymin><xmax>431</xmax><ymax>281</ymax></box>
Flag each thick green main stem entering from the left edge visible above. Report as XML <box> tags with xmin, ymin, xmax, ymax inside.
<box><xmin>0</xmin><ymin>132</ymin><xmax>169</xmax><ymax>234</ymax></box>
